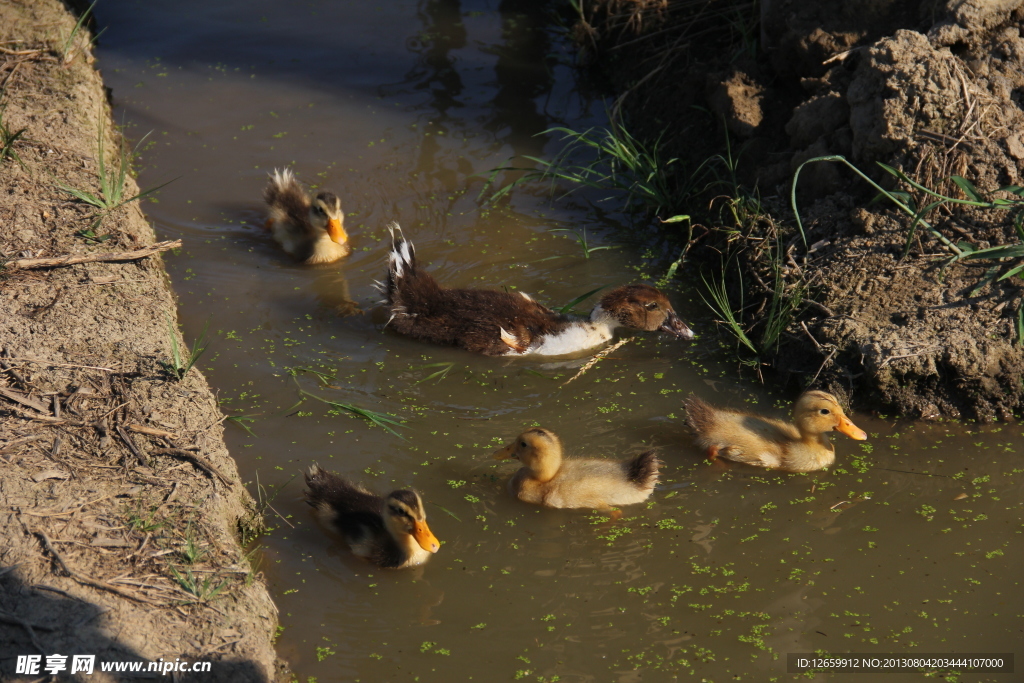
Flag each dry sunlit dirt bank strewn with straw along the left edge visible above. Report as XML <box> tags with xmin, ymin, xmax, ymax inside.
<box><xmin>0</xmin><ymin>0</ymin><xmax>283</xmax><ymax>681</ymax></box>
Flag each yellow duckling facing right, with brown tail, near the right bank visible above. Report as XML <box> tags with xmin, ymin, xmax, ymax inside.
<box><xmin>685</xmin><ymin>391</ymin><xmax>867</xmax><ymax>472</ymax></box>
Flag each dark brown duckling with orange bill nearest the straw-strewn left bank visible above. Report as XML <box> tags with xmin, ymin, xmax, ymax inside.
<box><xmin>303</xmin><ymin>465</ymin><xmax>440</xmax><ymax>569</ymax></box>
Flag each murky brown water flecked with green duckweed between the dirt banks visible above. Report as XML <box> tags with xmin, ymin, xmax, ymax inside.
<box><xmin>97</xmin><ymin>0</ymin><xmax>1024</xmax><ymax>682</ymax></box>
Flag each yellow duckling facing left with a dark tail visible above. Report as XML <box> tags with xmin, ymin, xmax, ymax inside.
<box><xmin>495</xmin><ymin>427</ymin><xmax>662</xmax><ymax>508</ymax></box>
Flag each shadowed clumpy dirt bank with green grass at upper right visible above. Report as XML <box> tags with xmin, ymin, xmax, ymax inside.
<box><xmin>577</xmin><ymin>0</ymin><xmax>1024</xmax><ymax>420</ymax></box>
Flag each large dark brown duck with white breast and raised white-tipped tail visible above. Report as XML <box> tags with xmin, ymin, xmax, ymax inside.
<box><xmin>378</xmin><ymin>223</ymin><xmax>693</xmax><ymax>355</ymax></box>
